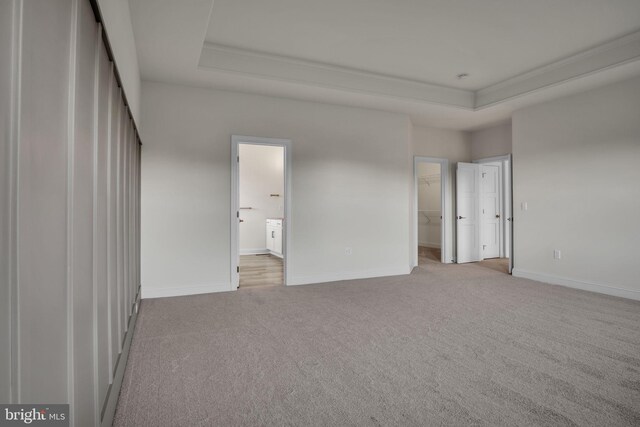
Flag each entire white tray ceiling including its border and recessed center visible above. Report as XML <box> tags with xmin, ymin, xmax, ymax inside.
<box><xmin>130</xmin><ymin>0</ymin><xmax>640</xmax><ymax>130</ymax></box>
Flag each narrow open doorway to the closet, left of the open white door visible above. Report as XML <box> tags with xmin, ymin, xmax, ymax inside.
<box><xmin>414</xmin><ymin>157</ymin><xmax>451</xmax><ymax>265</ymax></box>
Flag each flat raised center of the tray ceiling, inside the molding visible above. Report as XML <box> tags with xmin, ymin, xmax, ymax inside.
<box><xmin>206</xmin><ymin>0</ymin><xmax>640</xmax><ymax>90</ymax></box>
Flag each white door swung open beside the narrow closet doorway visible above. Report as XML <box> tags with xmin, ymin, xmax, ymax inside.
<box><xmin>456</xmin><ymin>163</ymin><xmax>481</xmax><ymax>263</ymax></box>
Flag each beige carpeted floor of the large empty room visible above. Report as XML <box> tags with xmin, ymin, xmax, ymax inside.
<box><xmin>114</xmin><ymin>256</ymin><xmax>640</xmax><ymax>426</ymax></box>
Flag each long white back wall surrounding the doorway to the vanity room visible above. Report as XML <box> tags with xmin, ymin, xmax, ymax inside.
<box><xmin>142</xmin><ymin>82</ymin><xmax>413</xmax><ymax>297</ymax></box>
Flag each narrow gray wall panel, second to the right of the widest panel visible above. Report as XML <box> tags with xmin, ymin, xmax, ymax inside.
<box><xmin>93</xmin><ymin>25</ymin><xmax>112</xmax><ymax>411</ymax></box>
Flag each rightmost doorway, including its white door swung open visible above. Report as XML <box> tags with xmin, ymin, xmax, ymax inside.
<box><xmin>456</xmin><ymin>155</ymin><xmax>513</xmax><ymax>273</ymax></box>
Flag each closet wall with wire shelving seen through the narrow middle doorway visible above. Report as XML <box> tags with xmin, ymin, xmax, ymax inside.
<box><xmin>417</xmin><ymin>163</ymin><xmax>442</xmax><ymax>248</ymax></box>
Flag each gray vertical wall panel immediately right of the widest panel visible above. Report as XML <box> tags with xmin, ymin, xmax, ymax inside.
<box><xmin>70</xmin><ymin>1</ymin><xmax>98</xmax><ymax>425</ymax></box>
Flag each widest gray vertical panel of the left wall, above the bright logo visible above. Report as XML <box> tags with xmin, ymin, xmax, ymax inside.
<box><xmin>17</xmin><ymin>0</ymin><xmax>72</xmax><ymax>403</ymax></box>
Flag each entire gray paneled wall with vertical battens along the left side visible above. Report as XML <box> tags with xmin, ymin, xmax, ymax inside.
<box><xmin>0</xmin><ymin>0</ymin><xmax>140</xmax><ymax>426</ymax></box>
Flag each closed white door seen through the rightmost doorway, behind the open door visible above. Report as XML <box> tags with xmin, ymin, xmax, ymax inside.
<box><xmin>480</xmin><ymin>163</ymin><xmax>502</xmax><ymax>259</ymax></box>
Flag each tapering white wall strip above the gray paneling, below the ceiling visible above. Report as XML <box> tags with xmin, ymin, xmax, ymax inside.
<box><xmin>98</xmin><ymin>0</ymin><xmax>142</xmax><ymax>126</ymax></box>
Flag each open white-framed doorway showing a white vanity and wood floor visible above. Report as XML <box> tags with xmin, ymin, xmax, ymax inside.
<box><xmin>231</xmin><ymin>136</ymin><xmax>291</xmax><ymax>290</ymax></box>
